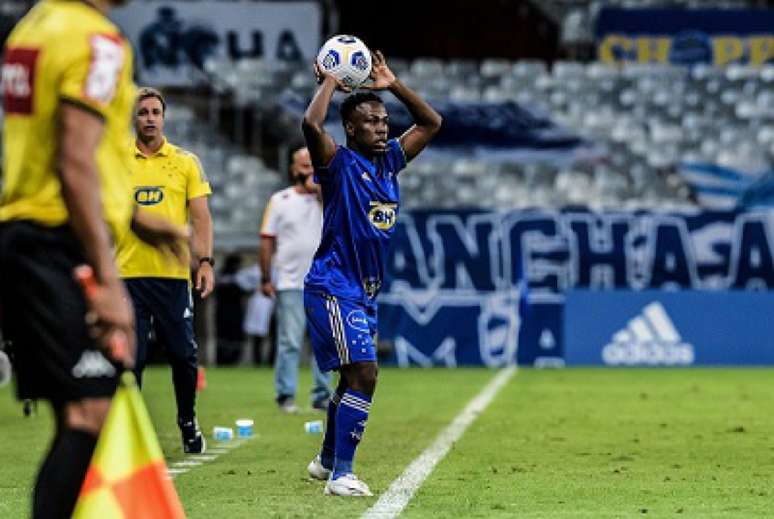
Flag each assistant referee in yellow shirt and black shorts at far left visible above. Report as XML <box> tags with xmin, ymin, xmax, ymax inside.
<box><xmin>0</xmin><ymin>0</ymin><xmax>184</xmax><ymax>518</ymax></box>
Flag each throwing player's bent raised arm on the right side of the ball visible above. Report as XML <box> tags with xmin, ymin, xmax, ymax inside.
<box><xmin>363</xmin><ymin>50</ymin><xmax>443</xmax><ymax>162</ymax></box>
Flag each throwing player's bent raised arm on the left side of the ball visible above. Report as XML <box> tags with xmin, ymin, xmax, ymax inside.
<box><xmin>301</xmin><ymin>63</ymin><xmax>348</xmax><ymax>168</ymax></box>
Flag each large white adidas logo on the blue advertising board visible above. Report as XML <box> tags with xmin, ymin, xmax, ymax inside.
<box><xmin>602</xmin><ymin>301</ymin><xmax>695</xmax><ymax>366</ymax></box>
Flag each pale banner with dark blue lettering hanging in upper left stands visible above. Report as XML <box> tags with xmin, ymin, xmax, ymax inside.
<box><xmin>111</xmin><ymin>0</ymin><xmax>321</xmax><ymax>86</ymax></box>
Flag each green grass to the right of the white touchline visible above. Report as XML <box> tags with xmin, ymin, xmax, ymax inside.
<box><xmin>406</xmin><ymin>369</ymin><xmax>774</xmax><ymax>518</ymax></box>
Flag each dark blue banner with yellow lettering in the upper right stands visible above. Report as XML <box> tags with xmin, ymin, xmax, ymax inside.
<box><xmin>596</xmin><ymin>8</ymin><xmax>774</xmax><ymax>66</ymax></box>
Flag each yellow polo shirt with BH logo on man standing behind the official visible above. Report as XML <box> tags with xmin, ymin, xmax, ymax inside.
<box><xmin>118</xmin><ymin>139</ymin><xmax>212</xmax><ymax>279</ymax></box>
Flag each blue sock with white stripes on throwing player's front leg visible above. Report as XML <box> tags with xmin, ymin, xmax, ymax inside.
<box><xmin>332</xmin><ymin>389</ymin><xmax>371</xmax><ymax>479</ymax></box>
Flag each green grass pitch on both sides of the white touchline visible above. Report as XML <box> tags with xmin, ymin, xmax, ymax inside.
<box><xmin>0</xmin><ymin>368</ymin><xmax>774</xmax><ymax>518</ymax></box>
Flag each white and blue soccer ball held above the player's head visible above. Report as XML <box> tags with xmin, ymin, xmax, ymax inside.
<box><xmin>317</xmin><ymin>34</ymin><xmax>371</xmax><ymax>88</ymax></box>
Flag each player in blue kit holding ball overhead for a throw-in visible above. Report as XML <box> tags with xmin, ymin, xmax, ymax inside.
<box><xmin>302</xmin><ymin>51</ymin><xmax>441</xmax><ymax>496</ymax></box>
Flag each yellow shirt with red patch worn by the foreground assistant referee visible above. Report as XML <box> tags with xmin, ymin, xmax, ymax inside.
<box><xmin>0</xmin><ymin>0</ymin><xmax>136</xmax><ymax>237</ymax></box>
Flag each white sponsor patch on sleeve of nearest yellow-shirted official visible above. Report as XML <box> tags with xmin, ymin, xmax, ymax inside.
<box><xmin>83</xmin><ymin>34</ymin><xmax>124</xmax><ymax>104</ymax></box>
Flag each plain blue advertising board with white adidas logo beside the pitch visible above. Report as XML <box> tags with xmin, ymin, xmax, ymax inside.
<box><xmin>564</xmin><ymin>291</ymin><xmax>774</xmax><ymax>366</ymax></box>
